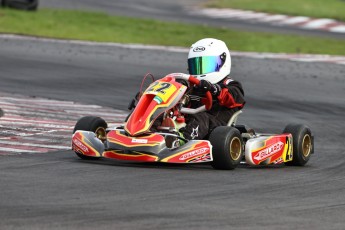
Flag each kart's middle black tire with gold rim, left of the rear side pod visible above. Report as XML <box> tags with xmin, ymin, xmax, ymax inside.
<box><xmin>209</xmin><ymin>126</ymin><xmax>243</xmax><ymax>170</ymax></box>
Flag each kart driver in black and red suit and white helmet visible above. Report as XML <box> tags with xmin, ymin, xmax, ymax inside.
<box><xmin>180</xmin><ymin>38</ymin><xmax>245</xmax><ymax>140</ymax></box>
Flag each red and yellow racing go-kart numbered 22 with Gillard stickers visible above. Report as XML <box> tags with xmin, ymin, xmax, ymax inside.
<box><xmin>72</xmin><ymin>73</ymin><xmax>314</xmax><ymax>169</ymax></box>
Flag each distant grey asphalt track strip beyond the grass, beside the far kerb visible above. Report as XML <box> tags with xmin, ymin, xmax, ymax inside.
<box><xmin>40</xmin><ymin>0</ymin><xmax>345</xmax><ymax>39</ymax></box>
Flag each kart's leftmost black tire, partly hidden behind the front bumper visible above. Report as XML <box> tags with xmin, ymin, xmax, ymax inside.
<box><xmin>73</xmin><ymin>116</ymin><xmax>108</xmax><ymax>160</ymax></box>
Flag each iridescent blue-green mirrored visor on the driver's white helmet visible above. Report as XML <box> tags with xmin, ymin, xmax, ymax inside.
<box><xmin>188</xmin><ymin>56</ymin><xmax>224</xmax><ymax>75</ymax></box>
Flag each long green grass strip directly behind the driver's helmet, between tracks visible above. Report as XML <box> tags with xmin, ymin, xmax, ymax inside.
<box><xmin>0</xmin><ymin>9</ymin><xmax>345</xmax><ymax>55</ymax></box>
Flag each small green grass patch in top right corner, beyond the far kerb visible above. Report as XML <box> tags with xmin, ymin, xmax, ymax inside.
<box><xmin>206</xmin><ymin>0</ymin><xmax>345</xmax><ymax>21</ymax></box>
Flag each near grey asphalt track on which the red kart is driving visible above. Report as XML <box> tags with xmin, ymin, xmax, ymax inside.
<box><xmin>0</xmin><ymin>36</ymin><xmax>345</xmax><ymax>229</ymax></box>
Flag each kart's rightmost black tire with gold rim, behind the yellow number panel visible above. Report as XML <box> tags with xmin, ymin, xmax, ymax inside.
<box><xmin>283</xmin><ymin>124</ymin><xmax>313</xmax><ymax>166</ymax></box>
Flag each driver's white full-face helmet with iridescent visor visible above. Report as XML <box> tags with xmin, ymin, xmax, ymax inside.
<box><xmin>188</xmin><ymin>38</ymin><xmax>231</xmax><ymax>84</ymax></box>
